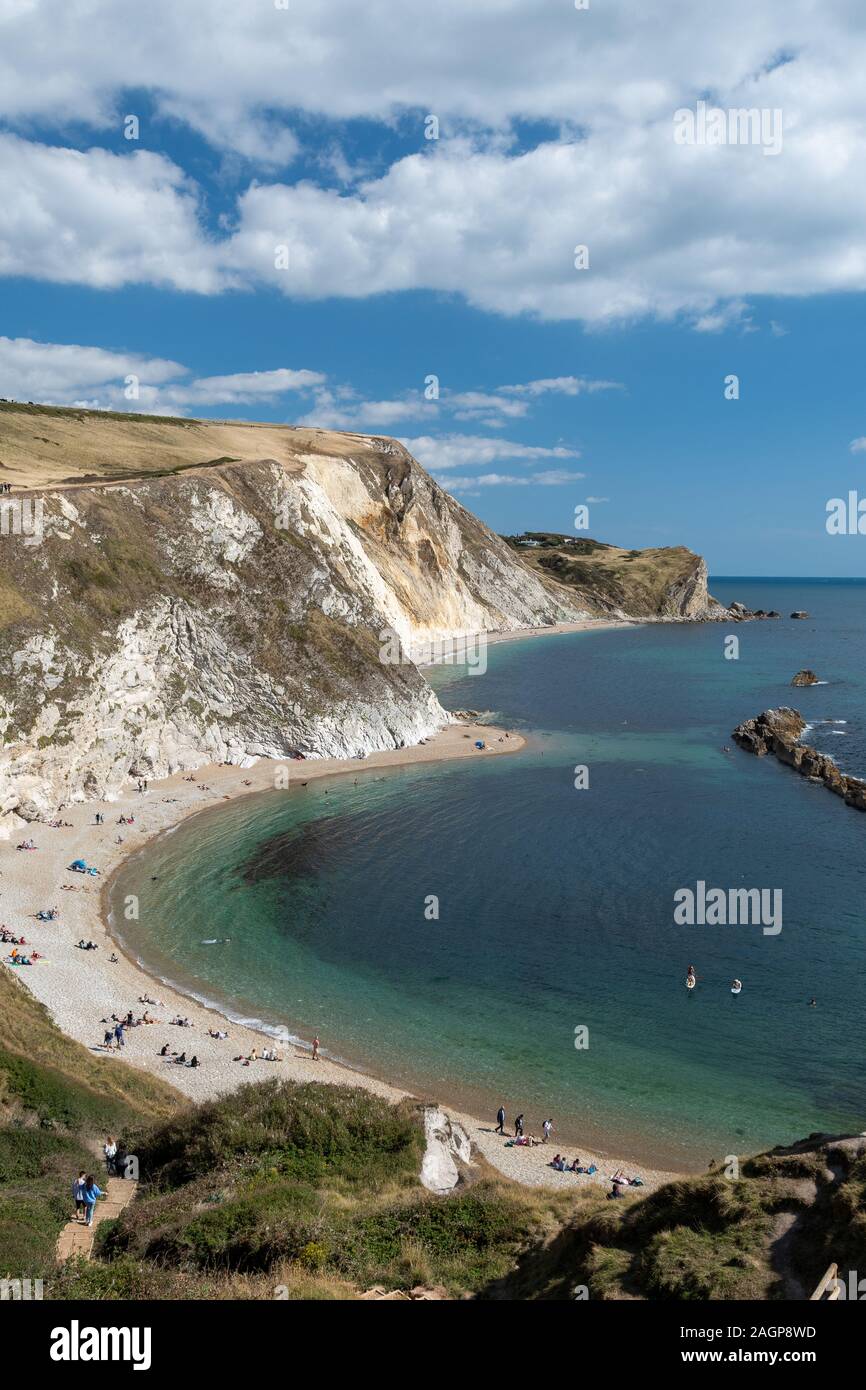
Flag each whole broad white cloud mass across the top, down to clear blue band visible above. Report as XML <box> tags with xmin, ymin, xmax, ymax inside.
<box><xmin>0</xmin><ymin>0</ymin><xmax>866</xmax><ymax>325</ymax></box>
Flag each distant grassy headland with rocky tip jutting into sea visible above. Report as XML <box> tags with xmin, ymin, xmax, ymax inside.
<box><xmin>500</xmin><ymin>531</ymin><xmax>730</xmax><ymax>621</ymax></box>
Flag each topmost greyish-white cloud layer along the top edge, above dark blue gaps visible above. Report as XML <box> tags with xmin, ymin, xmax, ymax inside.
<box><xmin>0</xmin><ymin>0</ymin><xmax>863</xmax><ymax>146</ymax></box>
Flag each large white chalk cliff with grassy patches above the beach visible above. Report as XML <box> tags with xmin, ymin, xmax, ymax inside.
<box><xmin>0</xmin><ymin>413</ymin><xmax>580</xmax><ymax>834</ymax></box>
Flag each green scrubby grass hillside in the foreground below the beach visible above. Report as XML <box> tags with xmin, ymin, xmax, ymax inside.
<box><xmin>0</xmin><ymin>970</ymin><xmax>866</xmax><ymax>1300</ymax></box>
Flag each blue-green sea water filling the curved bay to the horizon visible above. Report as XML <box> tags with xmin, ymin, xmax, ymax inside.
<box><xmin>114</xmin><ymin>580</ymin><xmax>866</xmax><ymax>1169</ymax></box>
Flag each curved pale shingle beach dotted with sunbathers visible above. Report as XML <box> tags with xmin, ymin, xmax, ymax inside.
<box><xmin>0</xmin><ymin>644</ymin><xmax>681</xmax><ymax>1191</ymax></box>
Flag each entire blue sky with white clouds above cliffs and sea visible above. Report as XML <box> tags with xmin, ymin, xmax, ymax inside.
<box><xmin>0</xmin><ymin>0</ymin><xmax>866</xmax><ymax>577</ymax></box>
